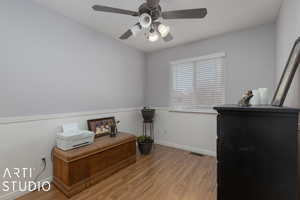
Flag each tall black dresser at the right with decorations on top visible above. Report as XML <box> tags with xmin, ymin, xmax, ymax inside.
<box><xmin>214</xmin><ymin>105</ymin><xmax>299</xmax><ymax>200</ymax></box>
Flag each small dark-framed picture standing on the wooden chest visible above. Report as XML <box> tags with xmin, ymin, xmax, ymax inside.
<box><xmin>88</xmin><ymin>117</ymin><xmax>116</xmax><ymax>138</ymax></box>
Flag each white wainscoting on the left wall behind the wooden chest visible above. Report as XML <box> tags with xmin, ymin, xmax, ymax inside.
<box><xmin>0</xmin><ymin>108</ymin><xmax>142</xmax><ymax>200</ymax></box>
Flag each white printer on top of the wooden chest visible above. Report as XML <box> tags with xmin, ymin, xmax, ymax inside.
<box><xmin>56</xmin><ymin>123</ymin><xmax>95</xmax><ymax>151</ymax></box>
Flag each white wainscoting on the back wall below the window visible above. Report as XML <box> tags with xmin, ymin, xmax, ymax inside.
<box><xmin>154</xmin><ymin>108</ymin><xmax>217</xmax><ymax>156</ymax></box>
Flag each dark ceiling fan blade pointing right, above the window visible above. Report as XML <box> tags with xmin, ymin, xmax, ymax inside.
<box><xmin>162</xmin><ymin>8</ymin><xmax>207</xmax><ymax>19</ymax></box>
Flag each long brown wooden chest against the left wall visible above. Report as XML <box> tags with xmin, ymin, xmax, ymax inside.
<box><xmin>53</xmin><ymin>133</ymin><xmax>136</xmax><ymax>197</ymax></box>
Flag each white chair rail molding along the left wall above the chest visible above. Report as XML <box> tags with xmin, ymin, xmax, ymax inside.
<box><xmin>0</xmin><ymin>107</ymin><xmax>141</xmax><ymax>125</ymax></box>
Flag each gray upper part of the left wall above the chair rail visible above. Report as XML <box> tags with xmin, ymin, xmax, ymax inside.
<box><xmin>0</xmin><ymin>0</ymin><xmax>145</xmax><ymax>117</ymax></box>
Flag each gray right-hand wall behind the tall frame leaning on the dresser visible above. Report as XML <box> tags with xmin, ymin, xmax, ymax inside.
<box><xmin>276</xmin><ymin>0</ymin><xmax>300</xmax><ymax>108</ymax></box>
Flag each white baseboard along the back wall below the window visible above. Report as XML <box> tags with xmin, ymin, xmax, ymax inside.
<box><xmin>155</xmin><ymin>141</ymin><xmax>217</xmax><ymax>157</ymax></box>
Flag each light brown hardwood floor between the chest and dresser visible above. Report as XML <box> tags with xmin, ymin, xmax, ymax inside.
<box><xmin>18</xmin><ymin>145</ymin><xmax>216</xmax><ymax>200</ymax></box>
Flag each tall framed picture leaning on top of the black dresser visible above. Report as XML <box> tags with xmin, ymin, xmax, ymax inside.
<box><xmin>272</xmin><ymin>37</ymin><xmax>300</xmax><ymax>107</ymax></box>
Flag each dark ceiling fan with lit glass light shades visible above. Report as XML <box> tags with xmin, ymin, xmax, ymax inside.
<box><xmin>93</xmin><ymin>0</ymin><xmax>207</xmax><ymax>42</ymax></box>
